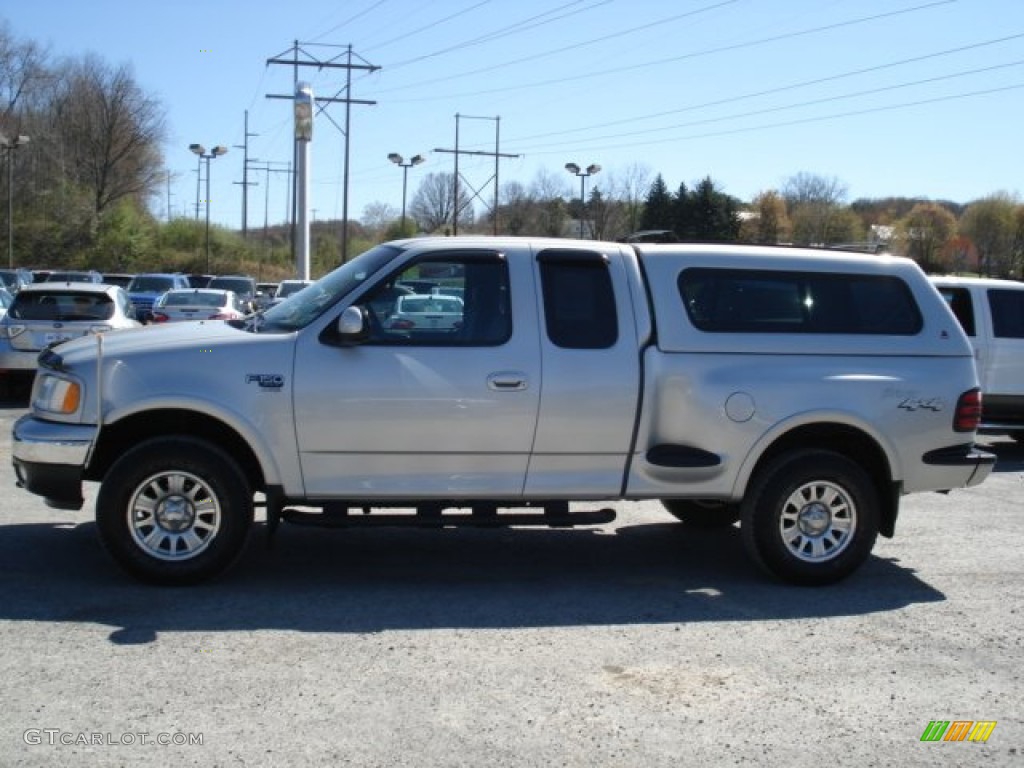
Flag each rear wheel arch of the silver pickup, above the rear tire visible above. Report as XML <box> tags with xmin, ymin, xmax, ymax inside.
<box><xmin>735</xmin><ymin>418</ymin><xmax>901</xmax><ymax>538</ymax></box>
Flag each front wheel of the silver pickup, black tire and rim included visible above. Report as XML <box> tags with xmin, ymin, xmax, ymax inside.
<box><xmin>96</xmin><ymin>436</ymin><xmax>253</xmax><ymax>586</ymax></box>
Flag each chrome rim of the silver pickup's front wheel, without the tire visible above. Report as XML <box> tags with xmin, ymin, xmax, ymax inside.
<box><xmin>127</xmin><ymin>471</ymin><xmax>222</xmax><ymax>561</ymax></box>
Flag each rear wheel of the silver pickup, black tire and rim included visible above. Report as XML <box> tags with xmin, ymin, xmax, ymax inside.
<box><xmin>740</xmin><ymin>451</ymin><xmax>879</xmax><ymax>586</ymax></box>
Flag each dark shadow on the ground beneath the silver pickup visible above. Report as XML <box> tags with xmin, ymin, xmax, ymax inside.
<box><xmin>0</xmin><ymin>521</ymin><xmax>945</xmax><ymax>644</ymax></box>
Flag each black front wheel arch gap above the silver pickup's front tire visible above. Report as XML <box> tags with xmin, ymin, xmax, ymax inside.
<box><xmin>84</xmin><ymin>408</ymin><xmax>267</xmax><ymax>490</ymax></box>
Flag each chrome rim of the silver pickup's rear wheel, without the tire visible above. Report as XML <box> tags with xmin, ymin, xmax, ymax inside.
<box><xmin>778</xmin><ymin>480</ymin><xmax>857</xmax><ymax>562</ymax></box>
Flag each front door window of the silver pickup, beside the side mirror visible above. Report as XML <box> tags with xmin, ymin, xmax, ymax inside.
<box><xmin>361</xmin><ymin>252</ymin><xmax>512</xmax><ymax>346</ymax></box>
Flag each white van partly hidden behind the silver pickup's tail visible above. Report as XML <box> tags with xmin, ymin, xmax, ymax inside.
<box><xmin>931</xmin><ymin>276</ymin><xmax>1024</xmax><ymax>443</ymax></box>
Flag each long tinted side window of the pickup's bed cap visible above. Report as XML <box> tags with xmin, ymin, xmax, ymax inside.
<box><xmin>678</xmin><ymin>267</ymin><xmax>924</xmax><ymax>336</ymax></box>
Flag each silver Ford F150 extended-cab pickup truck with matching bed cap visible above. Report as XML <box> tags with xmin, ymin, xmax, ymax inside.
<box><xmin>12</xmin><ymin>238</ymin><xmax>994</xmax><ymax>585</ymax></box>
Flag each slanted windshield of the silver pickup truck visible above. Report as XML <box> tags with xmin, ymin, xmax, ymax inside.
<box><xmin>251</xmin><ymin>245</ymin><xmax>401</xmax><ymax>333</ymax></box>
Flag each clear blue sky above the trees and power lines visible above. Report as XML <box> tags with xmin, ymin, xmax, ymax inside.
<box><xmin>0</xmin><ymin>0</ymin><xmax>1024</xmax><ymax>229</ymax></box>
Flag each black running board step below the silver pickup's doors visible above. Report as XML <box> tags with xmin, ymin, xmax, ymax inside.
<box><xmin>281</xmin><ymin>505</ymin><xmax>615</xmax><ymax>528</ymax></box>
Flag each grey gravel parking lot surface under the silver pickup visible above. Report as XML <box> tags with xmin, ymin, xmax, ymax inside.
<box><xmin>0</xmin><ymin>393</ymin><xmax>1024</xmax><ymax>768</ymax></box>
